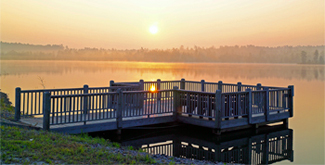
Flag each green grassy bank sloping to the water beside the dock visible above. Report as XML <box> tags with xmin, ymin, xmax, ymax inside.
<box><xmin>1</xmin><ymin>126</ymin><xmax>155</xmax><ymax>164</ymax></box>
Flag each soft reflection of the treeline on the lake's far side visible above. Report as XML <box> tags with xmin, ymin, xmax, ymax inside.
<box><xmin>1</xmin><ymin>61</ymin><xmax>324</xmax><ymax>81</ymax></box>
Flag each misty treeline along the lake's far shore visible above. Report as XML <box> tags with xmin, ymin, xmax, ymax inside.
<box><xmin>1</xmin><ymin>42</ymin><xmax>325</xmax><ymax>64</ymax></box>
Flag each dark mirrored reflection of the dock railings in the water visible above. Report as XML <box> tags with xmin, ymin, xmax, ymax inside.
<box><xmin>122</xmin><ymin>128</ymin><xmax>293</xmax><ymax>164</ymax></box>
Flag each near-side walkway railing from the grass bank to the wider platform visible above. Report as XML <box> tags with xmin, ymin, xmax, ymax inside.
<box><xmin>43</xmin><ymin>89</ymin><xmax>174</xmax><ymax>129</ymax></box>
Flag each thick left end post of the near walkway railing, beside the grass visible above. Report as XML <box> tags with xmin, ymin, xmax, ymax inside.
<box><xmin>43</xmin><ymin>92</ymin><xmax>51</xmax><ymax>131</ymax></box>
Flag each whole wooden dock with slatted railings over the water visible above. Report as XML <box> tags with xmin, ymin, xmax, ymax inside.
<box><xmin>15</xmin><ymin>79</ymin><xmax>294</xmax><ymax>134</ymax></box>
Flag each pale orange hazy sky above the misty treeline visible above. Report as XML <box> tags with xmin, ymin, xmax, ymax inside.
<box><xmin>1</xmin><ymin>0</ymin><xmax>325</xmax><ymax>49</ymax></box>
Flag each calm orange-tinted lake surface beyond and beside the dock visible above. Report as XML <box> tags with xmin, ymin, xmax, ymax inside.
<box><xmin>0</xmin><ymin>61</ymin><xmax>325</xmax><ymax>164</ymax></box>
